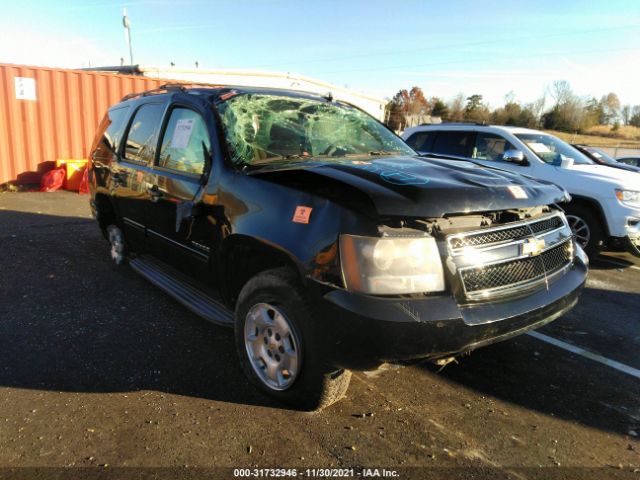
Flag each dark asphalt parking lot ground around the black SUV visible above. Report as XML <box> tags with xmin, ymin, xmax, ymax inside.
<box><xmin>0</xmin><ymin>192</ymin><xmax>640</xmax><ymax>479</ymax></box>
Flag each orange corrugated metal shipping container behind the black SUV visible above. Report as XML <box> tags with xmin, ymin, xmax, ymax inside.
<box><xmin>0</xmin><ymin>63</ymin><xmax>167</xmax><ymax>185</ymax></box>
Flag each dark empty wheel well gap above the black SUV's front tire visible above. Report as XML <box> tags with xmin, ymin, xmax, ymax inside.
<box><xmin>219</xmin><ymin>237</ymin><xmax>301</xmax><ymax>305</ymax></box>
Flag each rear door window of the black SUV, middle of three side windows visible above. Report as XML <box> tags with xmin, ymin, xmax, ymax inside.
<box><xmin>124</xmin><ymin>103</ymin><xmax>163</xmax><ymax>163</ymax></box>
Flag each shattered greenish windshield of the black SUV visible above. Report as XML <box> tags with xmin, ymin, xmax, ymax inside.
<box><xmin>217</xmin><ymin>94</ymin><xmax>415</xmax><ymax>166</ymax></box>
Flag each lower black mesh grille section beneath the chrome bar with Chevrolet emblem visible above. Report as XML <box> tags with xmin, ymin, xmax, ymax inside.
<box><xmin>461</xmin><ymin>240</ymin><xmax>573</xmax><ymax>294</ymax></box>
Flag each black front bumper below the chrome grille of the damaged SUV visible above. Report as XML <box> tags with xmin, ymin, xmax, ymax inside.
<box><xmin>316</xmin><ymin>257</ymin><xmax>588</xmax><ymax>370</ymax></box>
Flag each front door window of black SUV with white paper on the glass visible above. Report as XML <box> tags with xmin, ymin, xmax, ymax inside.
<box><xmin>158</xmin><ymin>108</ymin><xmax>211</xmax><ymax>175</ymax></box>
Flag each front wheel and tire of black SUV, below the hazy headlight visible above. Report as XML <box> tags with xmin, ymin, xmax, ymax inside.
<box><xmin>235</xmin><ymin>268</ymin><xmax>351</xmax><ymax>411</ymax></box>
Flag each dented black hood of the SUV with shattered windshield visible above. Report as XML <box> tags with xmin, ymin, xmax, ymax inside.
<box><xmin>247</xmin><ymin>156</ymin><xmax>568</xmax><ymax>218</ymax></box>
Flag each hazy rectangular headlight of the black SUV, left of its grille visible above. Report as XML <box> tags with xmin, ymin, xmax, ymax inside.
<box><xmin>340</xmin><ymin>235</ymin><xmax>444</xmax><ymax>295</ymax></box>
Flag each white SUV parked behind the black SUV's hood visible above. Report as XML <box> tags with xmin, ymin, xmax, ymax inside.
<box><xmin>402</xmin><ymin>123</ymin><xmax>640</xmax><ymax>256</ymax></box>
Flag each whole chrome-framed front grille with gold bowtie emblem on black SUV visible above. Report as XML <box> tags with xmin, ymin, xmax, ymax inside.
<box><xmin>446</xmin><ymin>213</ymin><xmax>573</xmax><ymax>300</ymax></box>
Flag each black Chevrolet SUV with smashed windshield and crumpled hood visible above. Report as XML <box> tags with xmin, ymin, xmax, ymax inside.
<box><xmin>89</xmin><ymin>85</ymin><xmax>587</xmax><ymax>409</ymax></box>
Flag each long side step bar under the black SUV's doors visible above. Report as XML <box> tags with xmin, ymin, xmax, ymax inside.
<box><xmin>129</xmin><ymin>257</ymin><xmax>234</xmax><ymax>327</ymax></box>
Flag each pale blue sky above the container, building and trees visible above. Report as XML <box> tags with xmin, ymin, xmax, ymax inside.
<box><xmin>0</xmin><ymin>0</ymin><xmax>640</xmax><ymax>106</ymax></box>
